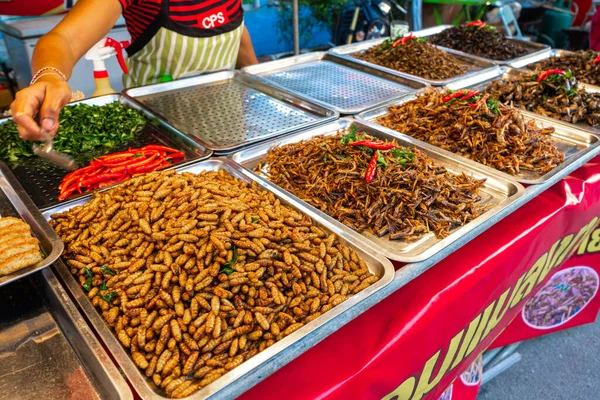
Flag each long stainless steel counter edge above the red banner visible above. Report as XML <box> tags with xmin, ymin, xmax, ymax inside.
<box><xmin>211</xmin><ymin>132</ymin><xmax>600</xmax><ymax>400</ymax></box>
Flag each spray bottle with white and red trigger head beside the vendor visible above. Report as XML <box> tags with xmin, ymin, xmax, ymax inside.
<box><xmin>85</xmin><ymin>37</ymin><xmax>129</xmax><ymax>97</ymax></box>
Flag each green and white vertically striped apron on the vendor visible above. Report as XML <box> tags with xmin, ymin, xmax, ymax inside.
<box><xmin>123</xmin><ymin>23</ymin><xmax>244</xmax><ymax>88</ymax></box>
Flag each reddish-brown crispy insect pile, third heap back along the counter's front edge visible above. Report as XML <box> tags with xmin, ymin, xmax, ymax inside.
<box><xmin>377</xmin><ymin>89</ymin><xmax>564</xmax><ymax>175</ymax></box>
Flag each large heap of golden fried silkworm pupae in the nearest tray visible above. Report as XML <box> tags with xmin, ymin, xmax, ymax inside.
<box><xmin>51</xmin><ymin>170</ymin><xmax>378</xmax><ymax>398</ymax></box>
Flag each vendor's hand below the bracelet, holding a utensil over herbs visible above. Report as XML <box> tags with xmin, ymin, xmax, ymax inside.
<box><xmin>10</xmin><ymin>74</ymin><xmax>71</xmax><ymax>141</ymax></box>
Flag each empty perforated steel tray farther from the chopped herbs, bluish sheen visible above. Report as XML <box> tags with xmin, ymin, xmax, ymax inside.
<box><xmin>243</xmin><ymin>52</ymin><xmax>427</xmax><ymax>114</ymax></box>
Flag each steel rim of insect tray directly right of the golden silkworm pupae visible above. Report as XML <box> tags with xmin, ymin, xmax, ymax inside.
<box><xmin>231</xmin><ymin>118</ymin><xmax>525</xmax><ymax>263</ymax></box>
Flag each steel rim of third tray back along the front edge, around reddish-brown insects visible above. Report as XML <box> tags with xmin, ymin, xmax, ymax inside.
<box><xmin>356</xmin><ymin>95</ymin><xmax>600</xmax><ymax>185</ymax></box>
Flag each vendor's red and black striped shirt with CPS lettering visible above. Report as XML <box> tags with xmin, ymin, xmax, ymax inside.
<box><xmin>119</xmin><ymin>0</ymin><xmax>244</xmax><ymax>55</ymax></box>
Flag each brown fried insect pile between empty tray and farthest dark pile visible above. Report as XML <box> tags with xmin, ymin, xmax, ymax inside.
<box><xmin>352</xmin><ymin>38</ymin><xmax>470</xmax><ymax>80</ymax></box>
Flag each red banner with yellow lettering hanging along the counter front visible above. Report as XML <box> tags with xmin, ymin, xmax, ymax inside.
<box><xmin>241</xmin><ymin>158</ymin><xmax>600</xmax><ymax>400</ymax></box>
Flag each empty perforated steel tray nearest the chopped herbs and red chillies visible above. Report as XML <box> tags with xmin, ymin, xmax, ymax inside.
<box><xmin>124</xmin><ymin>71</ymin><xmax>338</xmax><ymax>154</ymax></box>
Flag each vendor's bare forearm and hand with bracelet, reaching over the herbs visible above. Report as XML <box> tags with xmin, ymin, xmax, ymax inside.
<box><xmin>11</xmin><ymin>0</ymin><xmax>122</xmax><ymax>140</ymax></box>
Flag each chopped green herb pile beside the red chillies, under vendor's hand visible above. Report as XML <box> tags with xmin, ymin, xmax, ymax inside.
<box><xmin>0</xmin><ymin>102</ymin><xmax>146</xmax><ymax>166</ymax></box>
